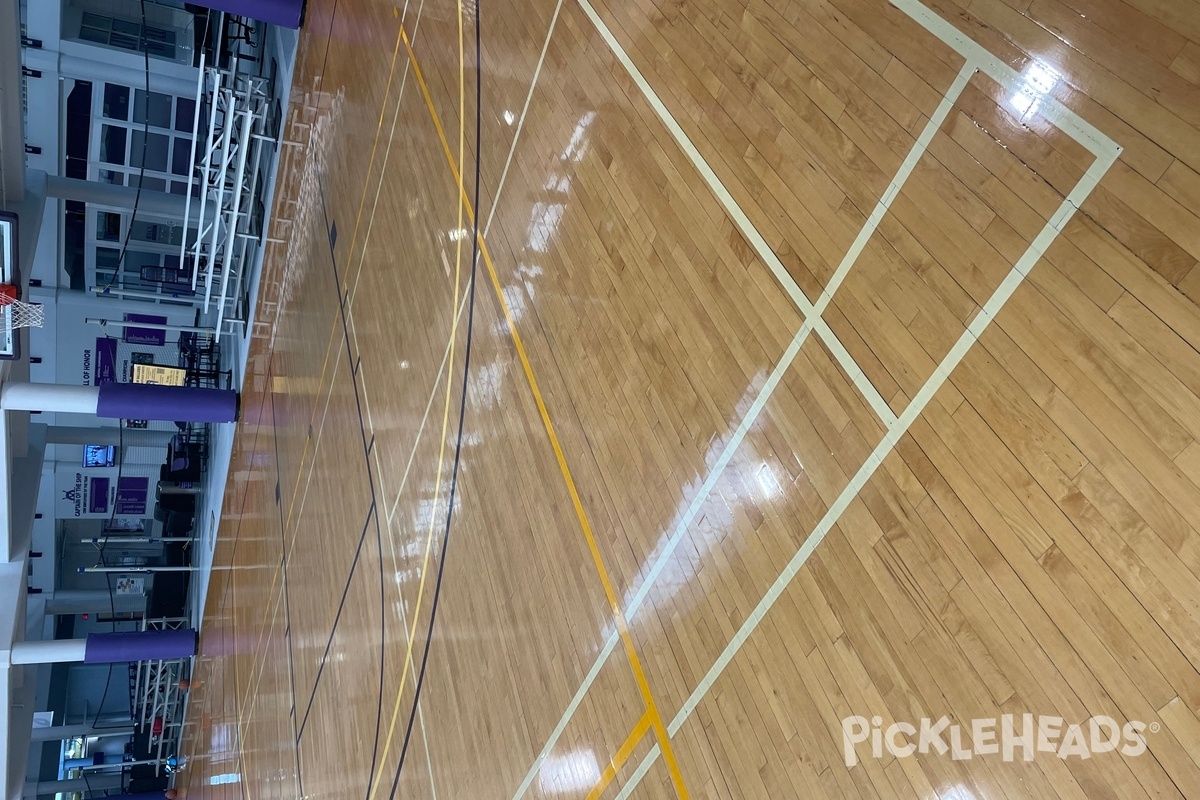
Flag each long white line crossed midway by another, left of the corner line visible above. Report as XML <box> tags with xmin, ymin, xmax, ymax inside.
<box><xmin>512</xmin><ymin>14</ymin><xmax>976</xmax><ymax>800</ymax></box>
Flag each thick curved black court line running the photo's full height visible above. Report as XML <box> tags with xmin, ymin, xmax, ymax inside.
<box><xmin>389</xmin><ymin>0</ymin><xmax>484</xmax><ymax>800</ymax></box>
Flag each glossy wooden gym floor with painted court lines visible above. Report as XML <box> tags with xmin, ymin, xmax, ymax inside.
<box><xmin>180</xmin><ymin>0</ymin><xmax>1200</xmax><ymax>800</ymax></box>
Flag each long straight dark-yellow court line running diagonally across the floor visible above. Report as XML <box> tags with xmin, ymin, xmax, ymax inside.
<box><xmin>400</xmin><ymin>25</ymin><xmax>690</xmax><ymax>800</ymax></box>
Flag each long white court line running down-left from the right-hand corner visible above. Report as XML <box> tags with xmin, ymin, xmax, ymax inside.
<box><xmin>618</xmin><ymin>130</ymin><xmax>1117</xmax><ymax>800</ymax></box>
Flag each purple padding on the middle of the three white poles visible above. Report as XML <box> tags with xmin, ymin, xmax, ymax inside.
<box><xmin>96</xmin><ymin>383</ymin><xmax>239</xmax><ymax>422</ymax></box>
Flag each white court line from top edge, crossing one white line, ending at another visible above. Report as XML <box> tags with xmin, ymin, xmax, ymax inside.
<box><xmin>568</xmin><ymin>0</ymin><xmax>895</xmax><ymax>423</ymax></box>
